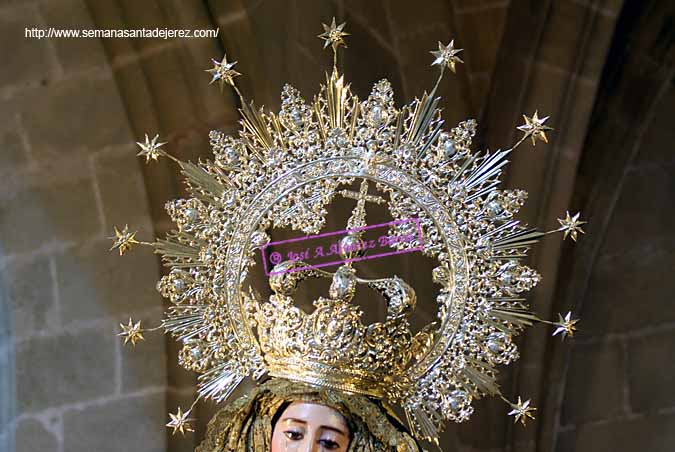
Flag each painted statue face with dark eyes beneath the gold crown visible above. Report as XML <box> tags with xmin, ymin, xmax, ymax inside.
<box><xmin>272</xmin><ymin>402</ymin><xmax>350</xmax><ymax>452</ymax></box>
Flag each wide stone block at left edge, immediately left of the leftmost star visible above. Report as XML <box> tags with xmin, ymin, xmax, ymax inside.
<box><xmin>0</xmin><ymin>178</ymin><xmax>101</xmax><ymax>254</ymax></box>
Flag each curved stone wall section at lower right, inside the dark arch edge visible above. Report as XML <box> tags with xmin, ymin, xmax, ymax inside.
<box><xmin>558</xmin><ymin>87</ymin><xmax>675</xmax><ymax>452</ymax></box>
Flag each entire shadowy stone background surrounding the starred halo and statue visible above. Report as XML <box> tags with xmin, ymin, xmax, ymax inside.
<box><xmin>0</xmin><ymin>0</ymin><xmax>675</xmax><ymax>452</ymax></box>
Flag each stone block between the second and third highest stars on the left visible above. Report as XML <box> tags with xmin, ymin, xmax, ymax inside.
<box><xmin>93</xmin><ymin>148</ymin><xmax>152</xmax><ymax>230</ymax></box>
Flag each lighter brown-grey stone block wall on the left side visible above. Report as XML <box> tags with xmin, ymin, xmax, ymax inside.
<box><xmin>0</xmin><ymin>0</ymin><xmax>166</xmax><ymax>452</ymax></box>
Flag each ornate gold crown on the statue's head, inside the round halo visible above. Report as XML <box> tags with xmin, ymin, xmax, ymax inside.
<box><xmin>260</xmin><ymin>260</ymin><xmax>428</xmax><ymax>398</ymax></box>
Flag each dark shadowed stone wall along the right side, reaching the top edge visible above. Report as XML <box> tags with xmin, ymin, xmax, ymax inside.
<box><xmin>551</xmin><ymin>2</ymin><xmax>675</xmax><ymax>452</ymax></box>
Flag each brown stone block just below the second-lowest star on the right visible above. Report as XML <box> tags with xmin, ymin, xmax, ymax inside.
<box><xmin>560</xmin><ymin>343</ymin><xmax>625</xmax><ymax>426</ymax></box>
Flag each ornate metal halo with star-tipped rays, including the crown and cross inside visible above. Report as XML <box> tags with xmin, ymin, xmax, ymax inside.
<box><xmin>112</xmin><ymin>19</ymin><xmax>584</xmax><ymax>443</ymax></box>
